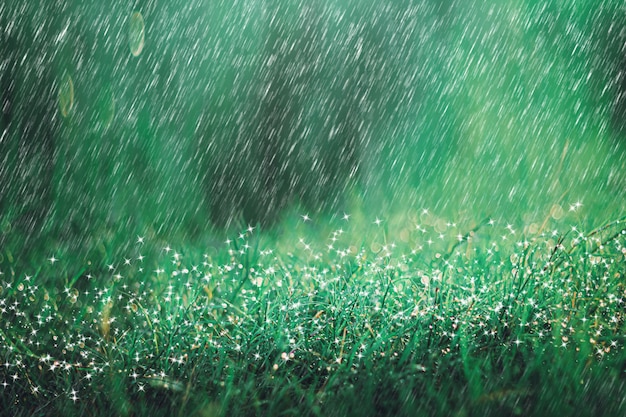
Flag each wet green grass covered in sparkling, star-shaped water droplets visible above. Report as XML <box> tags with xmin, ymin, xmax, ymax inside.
<box><xmin>0</xmin><ymin>210</ymin><xmax>626</xmax><ymax>416</ymax></box>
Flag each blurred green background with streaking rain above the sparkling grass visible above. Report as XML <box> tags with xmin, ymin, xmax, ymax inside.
<box><xmin>0</xmin><ymin>0</ymin><xmax>626</xmax><ymax>260</ymax></box>
